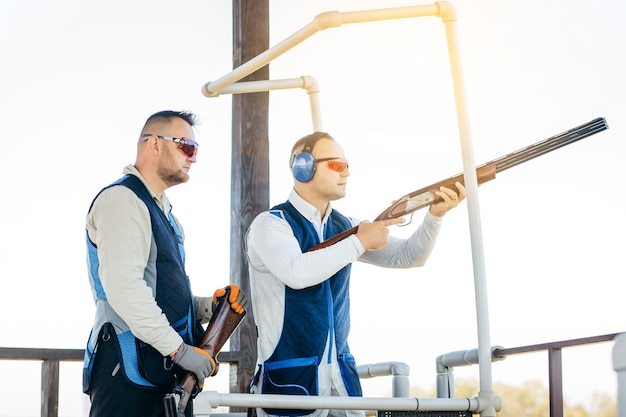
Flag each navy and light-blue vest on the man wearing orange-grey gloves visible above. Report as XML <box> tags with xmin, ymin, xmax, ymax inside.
<box><xmin>83</xmin><ymin>175</ymin><xmax>204</xmax><ymax>392</ymax></box>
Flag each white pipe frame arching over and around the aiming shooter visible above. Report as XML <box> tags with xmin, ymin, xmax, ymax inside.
<box><xmin>202</xmin><ymin>1</ymin><xmax>500</xmax><ymax>417</ymax></box>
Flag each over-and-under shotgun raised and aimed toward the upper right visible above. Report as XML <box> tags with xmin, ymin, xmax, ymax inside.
<box><xmin>307</xmin><ymin>117</ymin><xmax>608</xmax><ymax>252</ymax></box>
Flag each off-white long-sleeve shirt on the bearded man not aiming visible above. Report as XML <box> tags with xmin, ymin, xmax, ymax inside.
<box><xmin>87</xmin><ymin>165</ymin><xmax>184</xmax><ymax>356</ymax></box>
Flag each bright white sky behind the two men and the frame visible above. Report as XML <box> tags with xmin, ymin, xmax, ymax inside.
<box><xmin>0</xmin><ymin>0</ymin><xmax>626</xmax><ymax>416</ymax></box>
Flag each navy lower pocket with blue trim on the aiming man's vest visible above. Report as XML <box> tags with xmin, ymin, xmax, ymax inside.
<box><xmin>261</xmin><ymin>357</ymin><xmax>319</xmax><ymax>416</ymax></box>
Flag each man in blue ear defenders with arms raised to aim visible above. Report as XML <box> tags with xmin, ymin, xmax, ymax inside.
<box><xmin>246</xmin><ymin>132</ymin><xmax>465</xmax><ymax>417</ymax></box>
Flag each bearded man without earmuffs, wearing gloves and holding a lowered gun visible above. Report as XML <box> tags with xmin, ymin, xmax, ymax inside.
<box><xmin>83</xmin><ymin>110</ymin><xmax>246</xmax><ymax>417</ymax></box>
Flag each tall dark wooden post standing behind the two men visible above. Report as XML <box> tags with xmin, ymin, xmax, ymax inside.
<box><xmin>229</xmin><ymin>0</ymin><xmax>269</xmax><ymax>404</ymax></box>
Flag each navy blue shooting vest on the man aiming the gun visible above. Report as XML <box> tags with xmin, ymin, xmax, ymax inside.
<box><xmin>262</xmin><ymin>202</ymin><xmax>363</xmax><ymax>416</ymax></box>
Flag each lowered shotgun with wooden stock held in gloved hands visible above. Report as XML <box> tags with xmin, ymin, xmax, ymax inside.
<box><xmin>163</xmin><ymin>287</ymin><xmax>246</xmax><ymax>417</ymax></box>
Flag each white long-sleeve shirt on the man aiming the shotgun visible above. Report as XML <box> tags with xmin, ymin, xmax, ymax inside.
<box><xmin>246</xmin><ymin>190</ymin><xmax>442</xmax><ymax>417</ymax></box>
